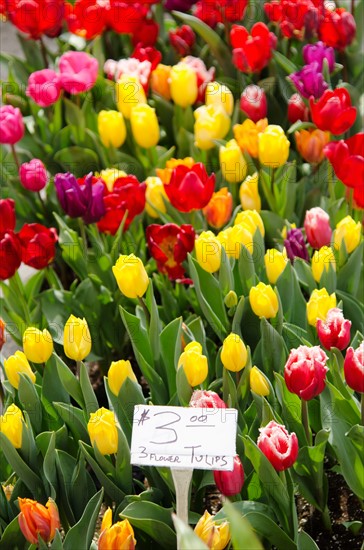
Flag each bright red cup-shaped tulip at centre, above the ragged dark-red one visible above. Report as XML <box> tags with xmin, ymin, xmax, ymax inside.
<box><xmin>164</xmin><ymin>162</ymin><xmax>215</xmax><ymax>212</ymax></box>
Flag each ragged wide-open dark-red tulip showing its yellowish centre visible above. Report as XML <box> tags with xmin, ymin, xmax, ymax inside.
<box><xmin>146</xmin><ymin>223</ymin><xmax>195</xmax><ymax>280</ymax></box>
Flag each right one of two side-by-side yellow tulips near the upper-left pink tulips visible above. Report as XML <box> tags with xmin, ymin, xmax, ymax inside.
<box><xmin>130</xmin><ymin>105</ymin><xmax>159</xmax><ymax>149</ymax></box>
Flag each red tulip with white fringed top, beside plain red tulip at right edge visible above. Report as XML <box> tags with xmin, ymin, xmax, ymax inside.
<box><xmin>284</xmin><ymin>346</ymin><xmax>329</xmax><ymax>401</ymax></box>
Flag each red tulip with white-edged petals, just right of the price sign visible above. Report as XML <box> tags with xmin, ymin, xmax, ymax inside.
<box><xmin>257</xmin><ymin>420</ymin><xmax>298</xmax><ymax>472</ymax></box>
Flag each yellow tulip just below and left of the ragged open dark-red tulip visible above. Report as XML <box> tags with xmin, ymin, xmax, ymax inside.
<box><xmin>112</xmin><ymin>254</ymin><xmax>149</xmax><ymax>298</ymax></box>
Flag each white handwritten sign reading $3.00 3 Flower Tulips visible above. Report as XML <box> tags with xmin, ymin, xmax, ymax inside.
<box><xmin>131</xmin><ymin>405</ymin><xmax>237</xmax><ymax>470</ymax></box>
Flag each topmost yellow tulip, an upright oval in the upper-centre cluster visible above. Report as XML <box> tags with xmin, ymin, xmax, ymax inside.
<box><xmin>170</xmin><ymin>63</ymin><xmax>198</xmax><ymax>109</ymax></box>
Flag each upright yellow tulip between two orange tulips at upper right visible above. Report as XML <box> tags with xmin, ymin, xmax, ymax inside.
<box><xmin>258</xmin><ymin>124</ymin><xmax>290</xmax><ymax>168</ymax></box>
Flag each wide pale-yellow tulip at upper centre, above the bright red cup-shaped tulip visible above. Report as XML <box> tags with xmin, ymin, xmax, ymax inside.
<box><xmin>194</xmin><ymin>105</ymin><xmax>230</xmax><ymax>150</ymax></box>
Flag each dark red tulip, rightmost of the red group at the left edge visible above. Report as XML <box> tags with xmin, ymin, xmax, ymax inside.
<box><xmin>19</xmin><ymin>223</ymin><xmax>58</xmax><ymax>269</ymax></box>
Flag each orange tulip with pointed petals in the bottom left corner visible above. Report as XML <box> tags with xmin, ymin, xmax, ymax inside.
<box><xmin>18</xmin><ymin>498</ymin><xmax>61</xmax><ymax>545</ymax></box>
